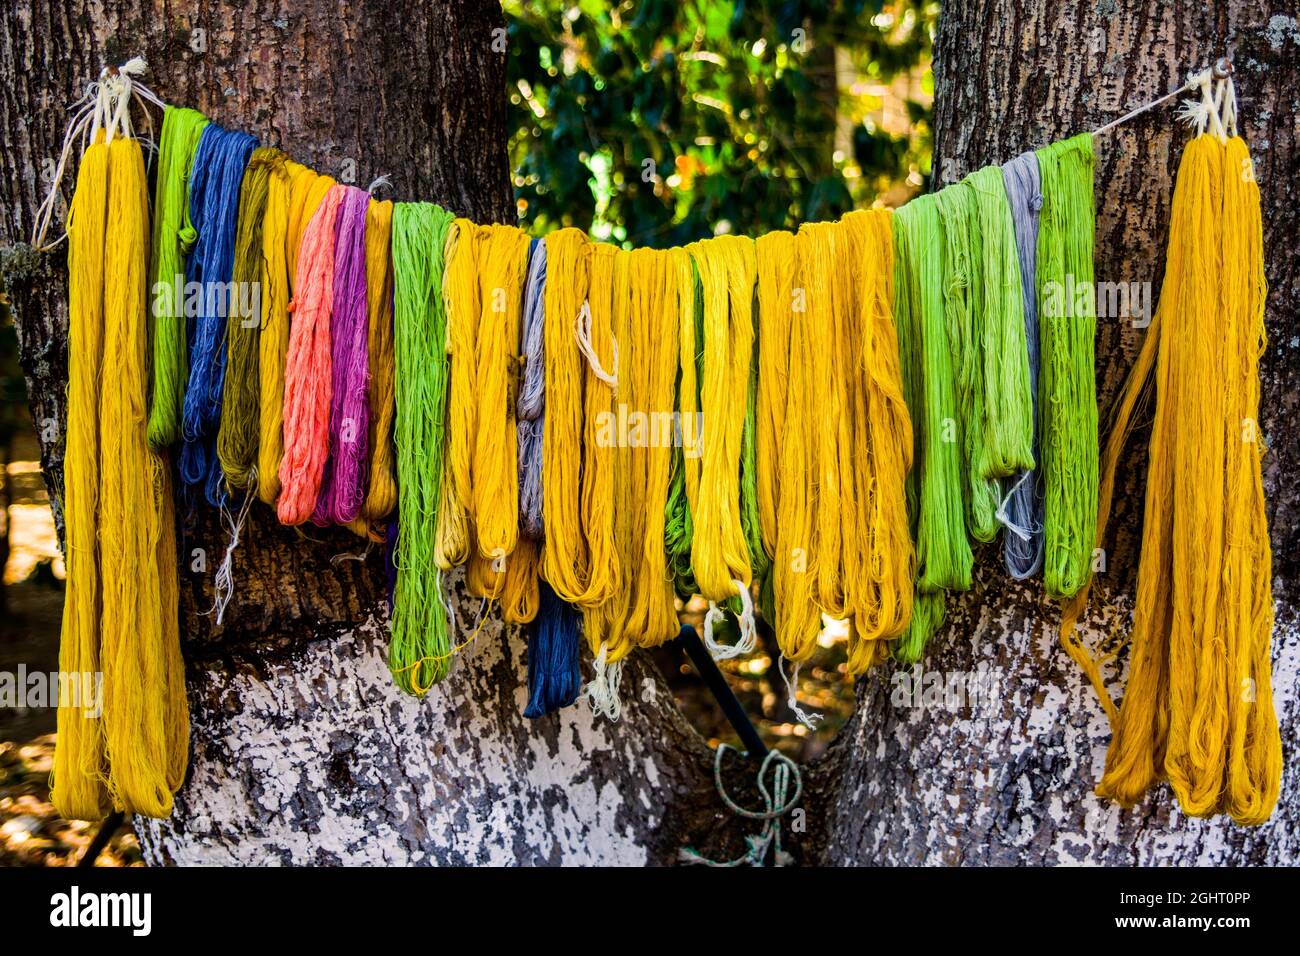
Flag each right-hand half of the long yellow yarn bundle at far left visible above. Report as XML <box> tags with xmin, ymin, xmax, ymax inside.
<box><xmin>99</xmin><ymin>138</ymin><xmax>190</xmax><ymax>817</ymax></box>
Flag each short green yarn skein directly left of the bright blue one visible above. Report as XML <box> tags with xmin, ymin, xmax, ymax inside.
<box><xmin>148</xmin><ymin>107</ymin><xmax>208</xmax><ymax>449</ymax></box>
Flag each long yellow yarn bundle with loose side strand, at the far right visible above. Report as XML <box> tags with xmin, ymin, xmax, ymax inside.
<box><xmin>1061</xmin><ymin>130</ymin><xmax>1282</xmax><ymax>825</ymax></box>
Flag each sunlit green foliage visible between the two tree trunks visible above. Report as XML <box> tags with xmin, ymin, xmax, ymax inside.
<box><xmin>504</xmin><ymin>0</ymin><xmax>937</xmax><ymax>247</ymax></box>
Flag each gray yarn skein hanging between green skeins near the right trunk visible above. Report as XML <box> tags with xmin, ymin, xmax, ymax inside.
<box><xmin>1001</xmin><ymin>152</ymin><xmax>1043</xmax><ymax>580</ymax></box>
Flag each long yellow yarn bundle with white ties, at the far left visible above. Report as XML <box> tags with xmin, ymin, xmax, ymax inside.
<box><xmin>52</xmin><ymin>117</ymin><xmax>189</xmax><ymax>819</ymax></box>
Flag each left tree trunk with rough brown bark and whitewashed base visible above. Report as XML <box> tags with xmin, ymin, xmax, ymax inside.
<box><xmin>0</xmin><ymin>0</ymin><xmax>740</xmax><ymax>864</ymax></box>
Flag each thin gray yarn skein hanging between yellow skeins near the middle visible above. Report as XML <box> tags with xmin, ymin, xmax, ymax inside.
<box><xmin>515</xmin><ymin>239</ymin><xmax>546</xmax><ymax>541</ymax></box>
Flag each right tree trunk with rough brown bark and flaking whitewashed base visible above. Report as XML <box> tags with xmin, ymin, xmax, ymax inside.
<box><xmin>827</xmin><ymin>0</ymin><xmax>1300</xmax><ymax>865</ymax></box>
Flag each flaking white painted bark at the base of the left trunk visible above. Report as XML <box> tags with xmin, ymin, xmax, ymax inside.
<box><xmin>137</xmin><ymin>574</ymin><xmax>722</xmax><ymax>865</ymax></box>
